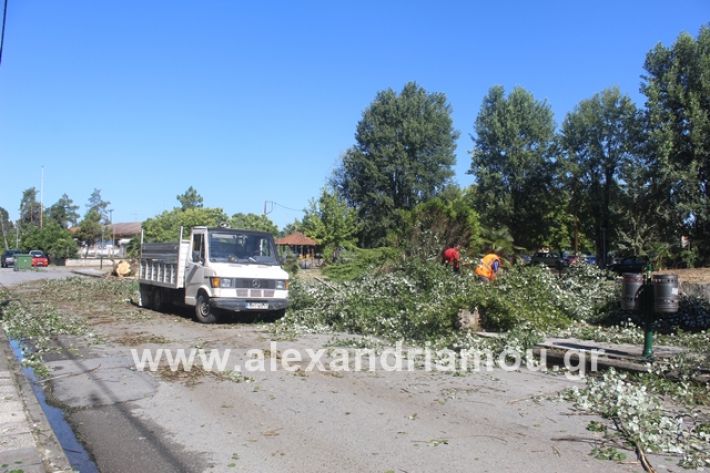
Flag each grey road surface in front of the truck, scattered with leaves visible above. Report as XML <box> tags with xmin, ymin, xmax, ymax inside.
<box><xmin>1</xmin><ymin>272</ymin><xmax>678</xmax><ymax>473</ymax></box>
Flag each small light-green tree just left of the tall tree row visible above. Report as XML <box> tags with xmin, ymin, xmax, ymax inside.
<box><xmin>303</xmin><ymin>189</ymin><xmax>360</xmax><ymax>261</ymax></box>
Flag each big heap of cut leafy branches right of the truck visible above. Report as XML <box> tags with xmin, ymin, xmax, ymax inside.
<box><xmin>286</xmin><ymin>256</ymin><xmax>613</xmax><ymax>338</ymax></box>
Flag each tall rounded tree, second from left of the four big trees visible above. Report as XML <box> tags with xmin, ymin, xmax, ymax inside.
<box><xmin>469</xmin><ymin>86</ymin><xmax>561</xmax><ymax>248</ymax></box>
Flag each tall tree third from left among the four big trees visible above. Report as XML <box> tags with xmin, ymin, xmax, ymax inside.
<box><xmin>561</xmin><ymin>88</ymin><xmax>641</xmax><ymax>266</ymax></box>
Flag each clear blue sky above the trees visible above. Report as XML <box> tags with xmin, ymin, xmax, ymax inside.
<box><xmin>0</xmin><ymin>0</ymin><xmax>710</xmax><ymax>226</ymax></box>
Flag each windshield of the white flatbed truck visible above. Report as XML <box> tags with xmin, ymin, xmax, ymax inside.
<box><xmin>209</xmin><ymin>231</ymin><xmax>278</xmax><ymax>265</ymax></box>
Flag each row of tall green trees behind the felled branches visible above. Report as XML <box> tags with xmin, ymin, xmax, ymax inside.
<box><xmin>324</xmin><ymin>27</ymin><xmax>710</xmax><ymax>265</ymax></box>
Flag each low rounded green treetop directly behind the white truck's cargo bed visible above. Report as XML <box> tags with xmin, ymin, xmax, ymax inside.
<box><xmin>143</xmin><ymin>207</ymin><xmax>228</xmax><ymax>243</ymax></box>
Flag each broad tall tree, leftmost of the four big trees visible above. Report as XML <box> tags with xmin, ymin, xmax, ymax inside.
<box><xmin>334</xmin><ymin>82</ymin><xmax>458</xmax><ymax>246</ymax></box>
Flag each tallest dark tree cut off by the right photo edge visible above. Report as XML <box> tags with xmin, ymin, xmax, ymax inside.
<box><xmin>641</xmin><ymin>26</ymin><xmax>710</xmax><ymax>262</ymax></box>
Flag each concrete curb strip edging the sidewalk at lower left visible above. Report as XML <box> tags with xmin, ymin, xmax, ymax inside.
<box><xmin>0</xmin><ymin>329</ymin><xmax>74</xmax><ymax>473</ymax></box>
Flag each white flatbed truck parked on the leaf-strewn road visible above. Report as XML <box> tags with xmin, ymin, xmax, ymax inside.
<box><xmin>139</xmin><ymin>227</ymin><xmax>288</xmax><ymax>323</ymax></box>
